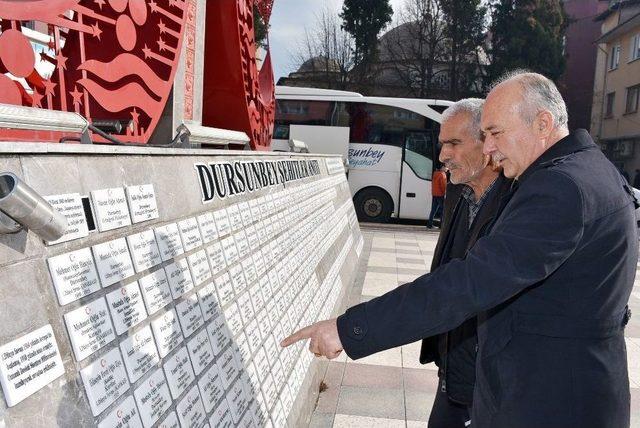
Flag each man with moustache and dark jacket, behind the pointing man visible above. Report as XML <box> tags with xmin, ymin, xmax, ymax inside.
<box><xmin>420</xmin><ymin>98</ymin><xmax>511</xmax><ymax>428</ymax></box>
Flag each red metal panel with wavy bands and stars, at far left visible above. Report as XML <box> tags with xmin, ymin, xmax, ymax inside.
<box><xmin>0</xmin><ymin>0</ymin><xmax>186</xmax><ymax>143</ymax></box>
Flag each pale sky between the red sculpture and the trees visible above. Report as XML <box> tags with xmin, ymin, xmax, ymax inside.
<box><xmin>269</xmin><ymin>0</ymin><xmax>404</xmax><ymax>82</ymax></box>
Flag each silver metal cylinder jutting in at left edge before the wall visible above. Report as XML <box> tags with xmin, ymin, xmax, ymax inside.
<box><xmin>0</xmin><ymin>172</ymin><xmax>67</xmax><ymax>241</ymax></box>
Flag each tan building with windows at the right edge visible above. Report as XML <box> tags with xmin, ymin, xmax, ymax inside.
<box><xmin>591</xmin><ymin>0</ymin><xmax>640</xmax><ymax>179</ymax></box>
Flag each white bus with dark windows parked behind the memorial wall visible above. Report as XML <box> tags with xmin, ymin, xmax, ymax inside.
<box><xmin>272</xmin><ymin>86</ymin><xmax>452</xmax><ymax>222</ymax></box>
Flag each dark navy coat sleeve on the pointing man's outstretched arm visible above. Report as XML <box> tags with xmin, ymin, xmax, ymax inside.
<box><xmin>338</xmin><ymin>170</ymin><xmax>584</xmax><ymax>359</ymax></box>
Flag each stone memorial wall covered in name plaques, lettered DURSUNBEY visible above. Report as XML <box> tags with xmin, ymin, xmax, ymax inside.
<box><xmin>0</xmin><ymin>144</ymin><xmax>363</xmax><ymax>428</ymax></box>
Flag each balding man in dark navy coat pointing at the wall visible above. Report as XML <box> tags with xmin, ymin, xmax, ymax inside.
<box><xmin>283</xmin><ymin>73</ymin><xmax>638</xmax><ymax>428</ymax></box>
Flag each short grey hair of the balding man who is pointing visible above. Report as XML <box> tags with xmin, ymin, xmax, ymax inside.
<box><xmin>491</xmin><ymin>70</ymin><xmax>569</xmax><ymax>129</ymax></box>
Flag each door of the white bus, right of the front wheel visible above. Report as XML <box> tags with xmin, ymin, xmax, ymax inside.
<box><xmin>399</xmin><ymin>130</ymin><xmax>435</xmax><ymax>220</ymax></box>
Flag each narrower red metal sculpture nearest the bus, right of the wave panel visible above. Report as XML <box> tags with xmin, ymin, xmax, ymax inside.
<box><xmin>202</xmin><ymin>0</ymin><xmax>275</xmax><ymax>150</ymax></box>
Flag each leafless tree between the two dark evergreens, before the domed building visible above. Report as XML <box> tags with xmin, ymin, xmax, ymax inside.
<box><xmin>380</xmin><ymin>0</ymin><xmax>448</xmax><ymax>98</ymax></box>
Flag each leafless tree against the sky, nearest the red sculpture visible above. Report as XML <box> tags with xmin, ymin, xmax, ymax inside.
<box><xmin>288</xmin><ymin>8</ymin><xmax>354</xmax><ymax>89</ymax></box>
